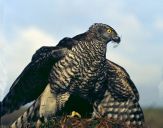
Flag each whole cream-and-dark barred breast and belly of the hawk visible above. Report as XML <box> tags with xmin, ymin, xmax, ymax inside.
<box><xmin>50</xmin><ymin>42</ymin><xmax>106</xmax><ymax>92</ymax></box>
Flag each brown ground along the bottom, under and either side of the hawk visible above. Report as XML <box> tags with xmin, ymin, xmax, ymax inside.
<box><xmin>1</xmin><ymin>108</ymin><xmax>163</xmax><ymax>128</ymax></box>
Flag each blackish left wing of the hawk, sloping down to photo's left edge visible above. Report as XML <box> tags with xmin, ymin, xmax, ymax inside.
<box><xmin>0</xmin><ymin>38</ymin><xmax>75</xmax><ymax>116</ymax></box>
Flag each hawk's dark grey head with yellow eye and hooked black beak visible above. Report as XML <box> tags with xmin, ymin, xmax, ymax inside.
<box><xmin>89</xmin><ymin>23</ymin><xmax>121</xmax><ymax>43</ymax></box>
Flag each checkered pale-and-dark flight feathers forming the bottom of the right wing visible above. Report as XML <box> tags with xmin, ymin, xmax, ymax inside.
<box><xmin>93</xmin><ymin>92</ymin><xmax>144</xmax><ymax>127</ymax></box>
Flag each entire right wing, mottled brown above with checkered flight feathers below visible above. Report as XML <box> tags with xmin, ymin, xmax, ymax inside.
<box><xmin>93</xmin><ymin>60</ymin><xmax>144</xmax><ymax>126</ymax></box>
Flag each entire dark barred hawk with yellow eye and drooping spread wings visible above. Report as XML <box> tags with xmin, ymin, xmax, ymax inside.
<box><xmin>0</xmin><ymin>23</ymin><xmax>144</xmax><ymax>128</ymax></box>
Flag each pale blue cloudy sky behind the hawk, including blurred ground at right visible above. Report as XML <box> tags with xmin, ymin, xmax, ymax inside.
<box><xmin>0</xmin><ymin>0</ymin><xmax>163</xmax><ymax>128</ymax></box>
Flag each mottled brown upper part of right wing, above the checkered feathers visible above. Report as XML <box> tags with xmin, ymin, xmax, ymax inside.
<box><xmin>107</xmin><ymin>60</ymin><xmax>139</xmax><ymax>100</ymax></box>
